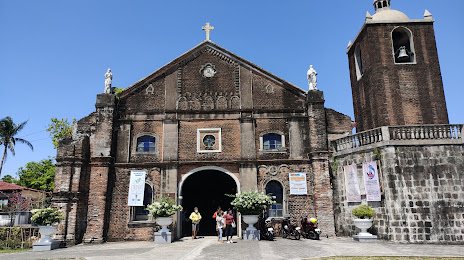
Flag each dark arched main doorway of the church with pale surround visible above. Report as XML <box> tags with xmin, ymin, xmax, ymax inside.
<box><xmin>177</xmin><ymin>166</ymin><xmax>240</xmax><ymax>237</ymax></box>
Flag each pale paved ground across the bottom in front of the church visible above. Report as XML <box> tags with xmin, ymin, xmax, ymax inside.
<box><xmin>4</xmin><ymin>237</ymin><xmax>464</xmax><ymax>260</ymax></box>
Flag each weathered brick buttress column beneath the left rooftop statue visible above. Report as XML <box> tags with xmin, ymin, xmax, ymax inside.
<box><xmin>84</xmin><ymin>94</ymin><xmax>115</xmax><ymax>243</ymax></box>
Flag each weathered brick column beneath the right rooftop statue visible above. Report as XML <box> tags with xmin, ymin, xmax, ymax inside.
<box><xmin>307</xmin><ymin>90</ymin><xmax>335</xmax><ymax>236</ymax></box>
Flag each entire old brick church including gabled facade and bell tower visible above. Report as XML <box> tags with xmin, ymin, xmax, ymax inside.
<box><xmin>53</xmin><ymin>0</ymin><xmax>464</xmax><ymax>244</ymax></box>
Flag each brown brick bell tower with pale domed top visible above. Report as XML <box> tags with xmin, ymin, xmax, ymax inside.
<box><xmin>347</xmin><ymin>0</ymin><xmax>449</xmax><ymax>132</ymax></box>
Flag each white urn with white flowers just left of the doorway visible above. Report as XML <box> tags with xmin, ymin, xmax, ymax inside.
<box><xmin>147</xmin><ymin>197</ymin><xmax>182</xmax><ymax>233</ymax></box>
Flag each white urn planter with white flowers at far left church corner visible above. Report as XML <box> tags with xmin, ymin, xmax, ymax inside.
<box><xmin>31</xmin><ymin>208</ymin><xmax>64</xmax><ymax>251</ymax></box>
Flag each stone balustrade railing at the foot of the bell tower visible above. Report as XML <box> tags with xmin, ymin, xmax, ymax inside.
<box><xmin>332</xmin><ymin>125</ymin><xmax>463</xmax><ymax>152</ymax></box>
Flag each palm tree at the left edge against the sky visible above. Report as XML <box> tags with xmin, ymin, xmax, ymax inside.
<box><xmin>0</xmin><ymin>116</ymin><xmax>34</xmax><ymax>176</ymax></box>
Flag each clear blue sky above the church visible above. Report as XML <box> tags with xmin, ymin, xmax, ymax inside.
<box><xmin>0</xmin><ymin>0</ymin><xmax>464</xmax><ymax>177</ymax></box>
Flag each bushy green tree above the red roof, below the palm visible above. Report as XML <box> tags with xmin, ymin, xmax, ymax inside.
<box><xmin>16</xmin><ymin>158</ymin><xmax>55</xmax><ymax>191</ymax></box>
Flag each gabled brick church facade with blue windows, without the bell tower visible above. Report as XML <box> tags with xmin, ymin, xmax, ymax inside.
<box><xmin>54</xmin><ymin>41</ymin><xmax>351</xmax><ymax>243</ymax></box>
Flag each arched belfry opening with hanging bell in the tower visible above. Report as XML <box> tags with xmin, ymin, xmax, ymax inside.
<box><xmin>392</xmin><ymin>27</ymin><xmax>416</xmax><ymax>63</ymax></box>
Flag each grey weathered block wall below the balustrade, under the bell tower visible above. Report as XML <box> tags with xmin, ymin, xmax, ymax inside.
<box><xmin>332</xmin><ymin>145</ymin><xmax>464</xmax><ymax>243</ymax></box>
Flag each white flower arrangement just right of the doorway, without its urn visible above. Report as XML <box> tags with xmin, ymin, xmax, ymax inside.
<box><xmin>231</xmin><ymin>191</ymin><xmax>275</xmax><ymax>215</ymax></box>
